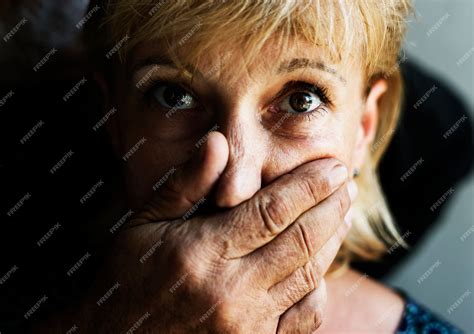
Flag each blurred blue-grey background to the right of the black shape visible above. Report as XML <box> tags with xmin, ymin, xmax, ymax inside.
<box><xmin>386</xmin><ymin>0</ymin><xmax>474</xmax><ymax>333</ymax></box>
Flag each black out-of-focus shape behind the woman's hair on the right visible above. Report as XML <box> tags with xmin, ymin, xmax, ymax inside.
<box><xmin>355</xmin><ymin>62</ymin><xmax>474</xmax><ymax>277</ymax></box>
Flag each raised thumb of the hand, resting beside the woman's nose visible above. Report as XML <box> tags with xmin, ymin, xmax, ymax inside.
<box><xmin>140</xmin><ymin>131</ymin><xmax>229</xmax><ymax>221</ymax></box>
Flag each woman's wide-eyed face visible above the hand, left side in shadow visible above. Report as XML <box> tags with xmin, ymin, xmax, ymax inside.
<box><xmin>109</xmin><ymin>37</ymin><xmax>385</xmax><ymax>206</ymax></box>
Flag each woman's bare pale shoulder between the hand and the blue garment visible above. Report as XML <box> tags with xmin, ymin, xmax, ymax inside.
<box><xmin>318</xmin><ymin>270</ymin><xmax>405</xmax><ymax>333</ymax></box>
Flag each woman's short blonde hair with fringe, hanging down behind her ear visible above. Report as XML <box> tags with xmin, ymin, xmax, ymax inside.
<box><xmin>89</xmin><ymin>0</ymin><xmax>411</xmax><ymax>264</ymax></box>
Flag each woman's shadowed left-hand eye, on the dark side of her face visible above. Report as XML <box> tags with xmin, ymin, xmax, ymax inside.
<box><xmin>151</xmin><ymin>84</ymin><xmax>197</xmax><ymax>110</ymax></box>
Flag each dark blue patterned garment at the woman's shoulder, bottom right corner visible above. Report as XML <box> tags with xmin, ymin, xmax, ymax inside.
<box><xmin>396</xmin><ymin>289</ymin><xmax>462</xmax><ymax>334</ymax></box>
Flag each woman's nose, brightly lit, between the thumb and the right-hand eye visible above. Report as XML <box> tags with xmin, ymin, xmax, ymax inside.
<box><xmin>216</xmin><ymin>106</ymin><xmax>267</xmax><ymax>207</ymax></box>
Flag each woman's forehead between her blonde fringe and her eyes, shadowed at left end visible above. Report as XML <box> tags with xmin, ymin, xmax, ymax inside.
<box><xmin>129</xmin><ymin>37</ymin><xmax>362</xmax><ymax>85</ymax></box>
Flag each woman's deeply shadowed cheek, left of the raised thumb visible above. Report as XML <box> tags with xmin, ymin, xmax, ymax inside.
<box><xmin>115</xmin><ymin>100</ymin><xmax>212</xmax><ymax>207</ymax></box>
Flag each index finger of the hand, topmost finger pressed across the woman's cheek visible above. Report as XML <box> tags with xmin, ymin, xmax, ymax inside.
<box><xmin>219</xmin><ymin>158</ymin><xmax>348</xmax><ymax>258</ymax></box>
